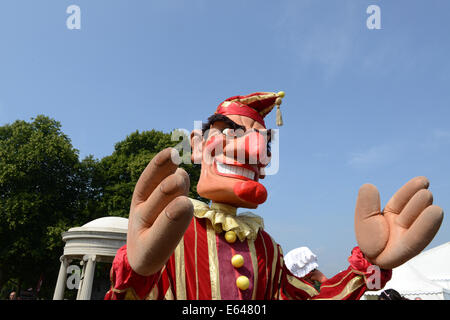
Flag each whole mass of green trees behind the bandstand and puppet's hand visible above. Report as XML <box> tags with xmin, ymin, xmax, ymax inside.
<box><xmin>0</xmin><ymin>115</ymin><xmax>201</xmax><ymax>299</ymax></box>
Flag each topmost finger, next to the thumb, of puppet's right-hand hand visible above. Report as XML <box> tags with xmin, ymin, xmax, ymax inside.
<box><xmin>384</xmin><ymin>177</ymin><xmax>430</xmax><ymax>214</ymax></box>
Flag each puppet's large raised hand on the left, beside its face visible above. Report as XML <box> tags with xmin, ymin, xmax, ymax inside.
<box><xmin>127</xmin><ymin>148</ymin><xmax>193</xmax><ymax>276</ymax></box>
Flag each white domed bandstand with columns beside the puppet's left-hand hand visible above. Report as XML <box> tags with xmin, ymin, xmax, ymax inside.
<box><xmin>53</xmin><ymin>217</ymin><xmax>128</xmax><ymax>300</ymax></box>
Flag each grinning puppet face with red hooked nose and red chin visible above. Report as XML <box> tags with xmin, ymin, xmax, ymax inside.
<box><xmin>191</xmin><ymin>115</ymin><xmax>270</xmax><ymax>208</ymax></box>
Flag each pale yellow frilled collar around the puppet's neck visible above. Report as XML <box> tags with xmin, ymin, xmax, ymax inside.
<box><xmin>190</xmin><ymin>199</ymin><xmax>264</xmax><ymax>241</ymax></box>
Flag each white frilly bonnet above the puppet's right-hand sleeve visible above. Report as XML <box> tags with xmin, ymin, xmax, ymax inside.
<box><xmin>284</xmin><ymin>247</ymin><xmax>319</xmax><ymax>278</ymax></box>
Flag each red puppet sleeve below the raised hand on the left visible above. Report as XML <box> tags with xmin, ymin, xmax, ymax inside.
<box><xmin>105</xmin><ymin>245</ymin><xmax>161</xmax><ymax>300</ymax></box>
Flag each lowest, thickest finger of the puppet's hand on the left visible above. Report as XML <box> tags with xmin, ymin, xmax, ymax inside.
<box><xmin>128</xmin><ymin>196</ymin><xmax>194</xmax><ymax>276</ymax></box>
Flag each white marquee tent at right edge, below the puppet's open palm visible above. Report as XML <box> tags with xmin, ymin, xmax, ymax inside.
<box><xmin>363</xmin><ymin>242</ymin><xmax>450</xmax><ymax>300</ymax></box>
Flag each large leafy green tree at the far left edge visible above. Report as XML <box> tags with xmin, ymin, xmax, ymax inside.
<box><xmin>0</xmin><ymin>116</ymin><xmax>86</xmax><ymax>298</ymax></box>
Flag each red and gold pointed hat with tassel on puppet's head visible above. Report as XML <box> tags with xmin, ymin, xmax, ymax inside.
<box><xmin>215</xmin><ymin>91</ymin><xmax>284</xmax><ymax>128</ymax></box>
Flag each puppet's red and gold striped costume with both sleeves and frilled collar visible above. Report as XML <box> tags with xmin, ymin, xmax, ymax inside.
<box><xmin>105</xmin><ymin>200</ymin><xmax>391</xmax><ymax>300</ymax></box>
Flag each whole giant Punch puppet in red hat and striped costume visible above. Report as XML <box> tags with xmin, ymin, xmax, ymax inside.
<box><xmin>105</xmin><ymin>92</ymin><xmax>443</xmax><ymax>300</ymax></box>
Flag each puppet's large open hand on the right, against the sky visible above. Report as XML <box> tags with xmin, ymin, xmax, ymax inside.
<box><xmin>355</xmin><ymin>177</ymin><xmax>443</xmax><ymax>269</ymax></box>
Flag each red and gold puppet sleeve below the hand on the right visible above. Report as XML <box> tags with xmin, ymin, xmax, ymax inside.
<box><xmin>279</xmin><ymin>247</ymin><xmax>392</xmax><ymax>300</ymax></box>
